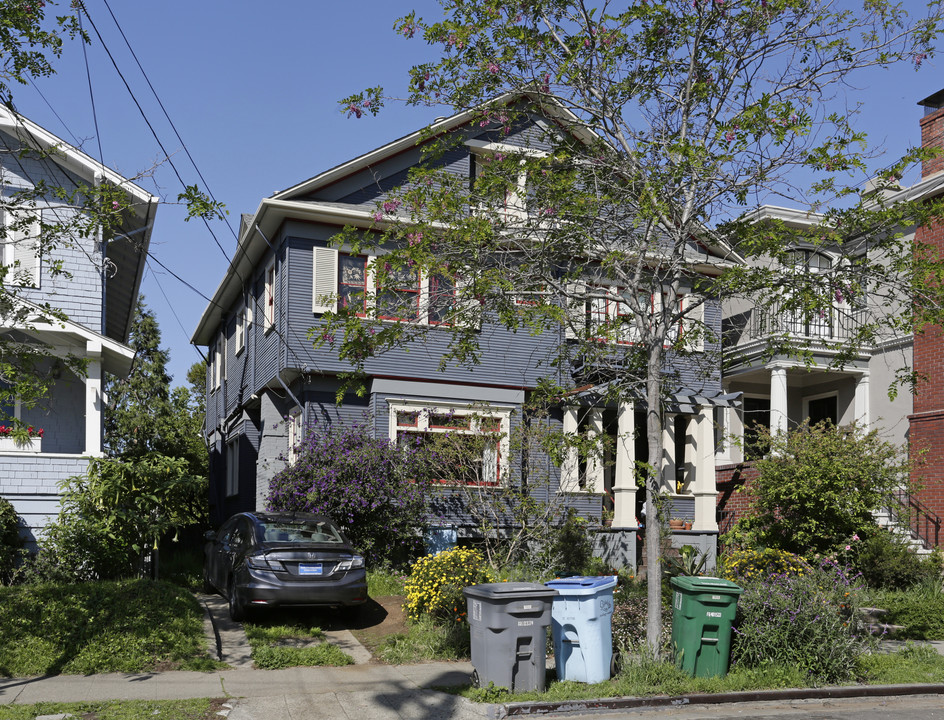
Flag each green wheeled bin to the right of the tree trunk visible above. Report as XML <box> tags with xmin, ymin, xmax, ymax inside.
<box><xmin>672</xmin><ymin>576</ymin><xmax>743</xmax><ymax>677</ymax></box>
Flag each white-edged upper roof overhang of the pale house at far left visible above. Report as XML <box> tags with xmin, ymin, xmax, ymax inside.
<box><xmin>0</xmin><ymin>105</ymin><xmax>159</xmax><ymax>342</ymax></box>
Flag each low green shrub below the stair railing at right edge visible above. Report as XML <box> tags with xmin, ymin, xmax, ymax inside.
<box><xmin>839</xmin><ymin>530</ymin><xmax>941</xmax><ymax>590</ymax></box>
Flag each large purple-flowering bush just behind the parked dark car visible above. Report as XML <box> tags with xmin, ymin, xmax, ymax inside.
<box><xmin>266</xmin><ymin>424</ymin><xmax>426</xmax><ymax>563</ymax></box>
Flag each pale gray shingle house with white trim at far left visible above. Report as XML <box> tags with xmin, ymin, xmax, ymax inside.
<box><xmin>0</xmin><ymin>108</ymin><xmax>158</xmax><ymax>543</ymax></box>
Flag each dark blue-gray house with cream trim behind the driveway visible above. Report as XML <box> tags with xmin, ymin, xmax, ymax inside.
<box><xmin>192</xmin><ymin>97</ymin><xmax>721</xmax><ymax>564</ymax></box>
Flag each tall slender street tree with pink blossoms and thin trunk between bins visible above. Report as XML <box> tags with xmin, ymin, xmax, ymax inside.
<box><xmin>328</xmin><ymin>0</ymin><xmax>942</xmax><ymax>649</ymax></box>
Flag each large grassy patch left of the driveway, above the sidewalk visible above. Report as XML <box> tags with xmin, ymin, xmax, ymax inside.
<box><xmin>0</xmin><ymin>580</ymin><xmax>219</xmax><ymax>677</ymax></box>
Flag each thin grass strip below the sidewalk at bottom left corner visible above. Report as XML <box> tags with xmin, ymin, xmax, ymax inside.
<box><xmin>0</xmin><ymin>698</ymin><xmax>226</xmax><ymax>720</ymax></box>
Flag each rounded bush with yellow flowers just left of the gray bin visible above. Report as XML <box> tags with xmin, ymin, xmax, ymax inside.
<box><xmin>403</xmin><ymin>548</ymin><xmax>494</xmax><ymax>622</ymax></box>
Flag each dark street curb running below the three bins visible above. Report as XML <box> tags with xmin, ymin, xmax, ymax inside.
<box><xmin>487</xmin><ymin>684</ymin><xmax>944</xmax><ymax>720</ymax></box>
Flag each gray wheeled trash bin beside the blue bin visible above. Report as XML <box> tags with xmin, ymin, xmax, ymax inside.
<box><xmin>462</xmin><ymin>582</ymin><xmax>557</xmax><ymax>692</ymax></box>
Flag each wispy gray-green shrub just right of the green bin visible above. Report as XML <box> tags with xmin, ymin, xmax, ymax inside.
<box><xmin>731</xmin><ymin>561</ymin><xmax>874</xmax><ymax>684</ymax></box>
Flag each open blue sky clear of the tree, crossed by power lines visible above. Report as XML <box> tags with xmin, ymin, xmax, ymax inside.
<box><xmin>14</xmin><ymin>0</ymin><xmax>944</xmax><ymax>384</ymax></box>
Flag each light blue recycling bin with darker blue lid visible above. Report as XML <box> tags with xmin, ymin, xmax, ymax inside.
<box><xmin>544</xmin><ymin>576</ymin><xmax>616</xmax><ymax>683</ymax></box>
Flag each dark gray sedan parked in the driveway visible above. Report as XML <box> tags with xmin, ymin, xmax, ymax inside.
<box><xmin>203</xmin><ymin>512</ymin><xmax>367</xmax><ymax>621</ymax></box>
